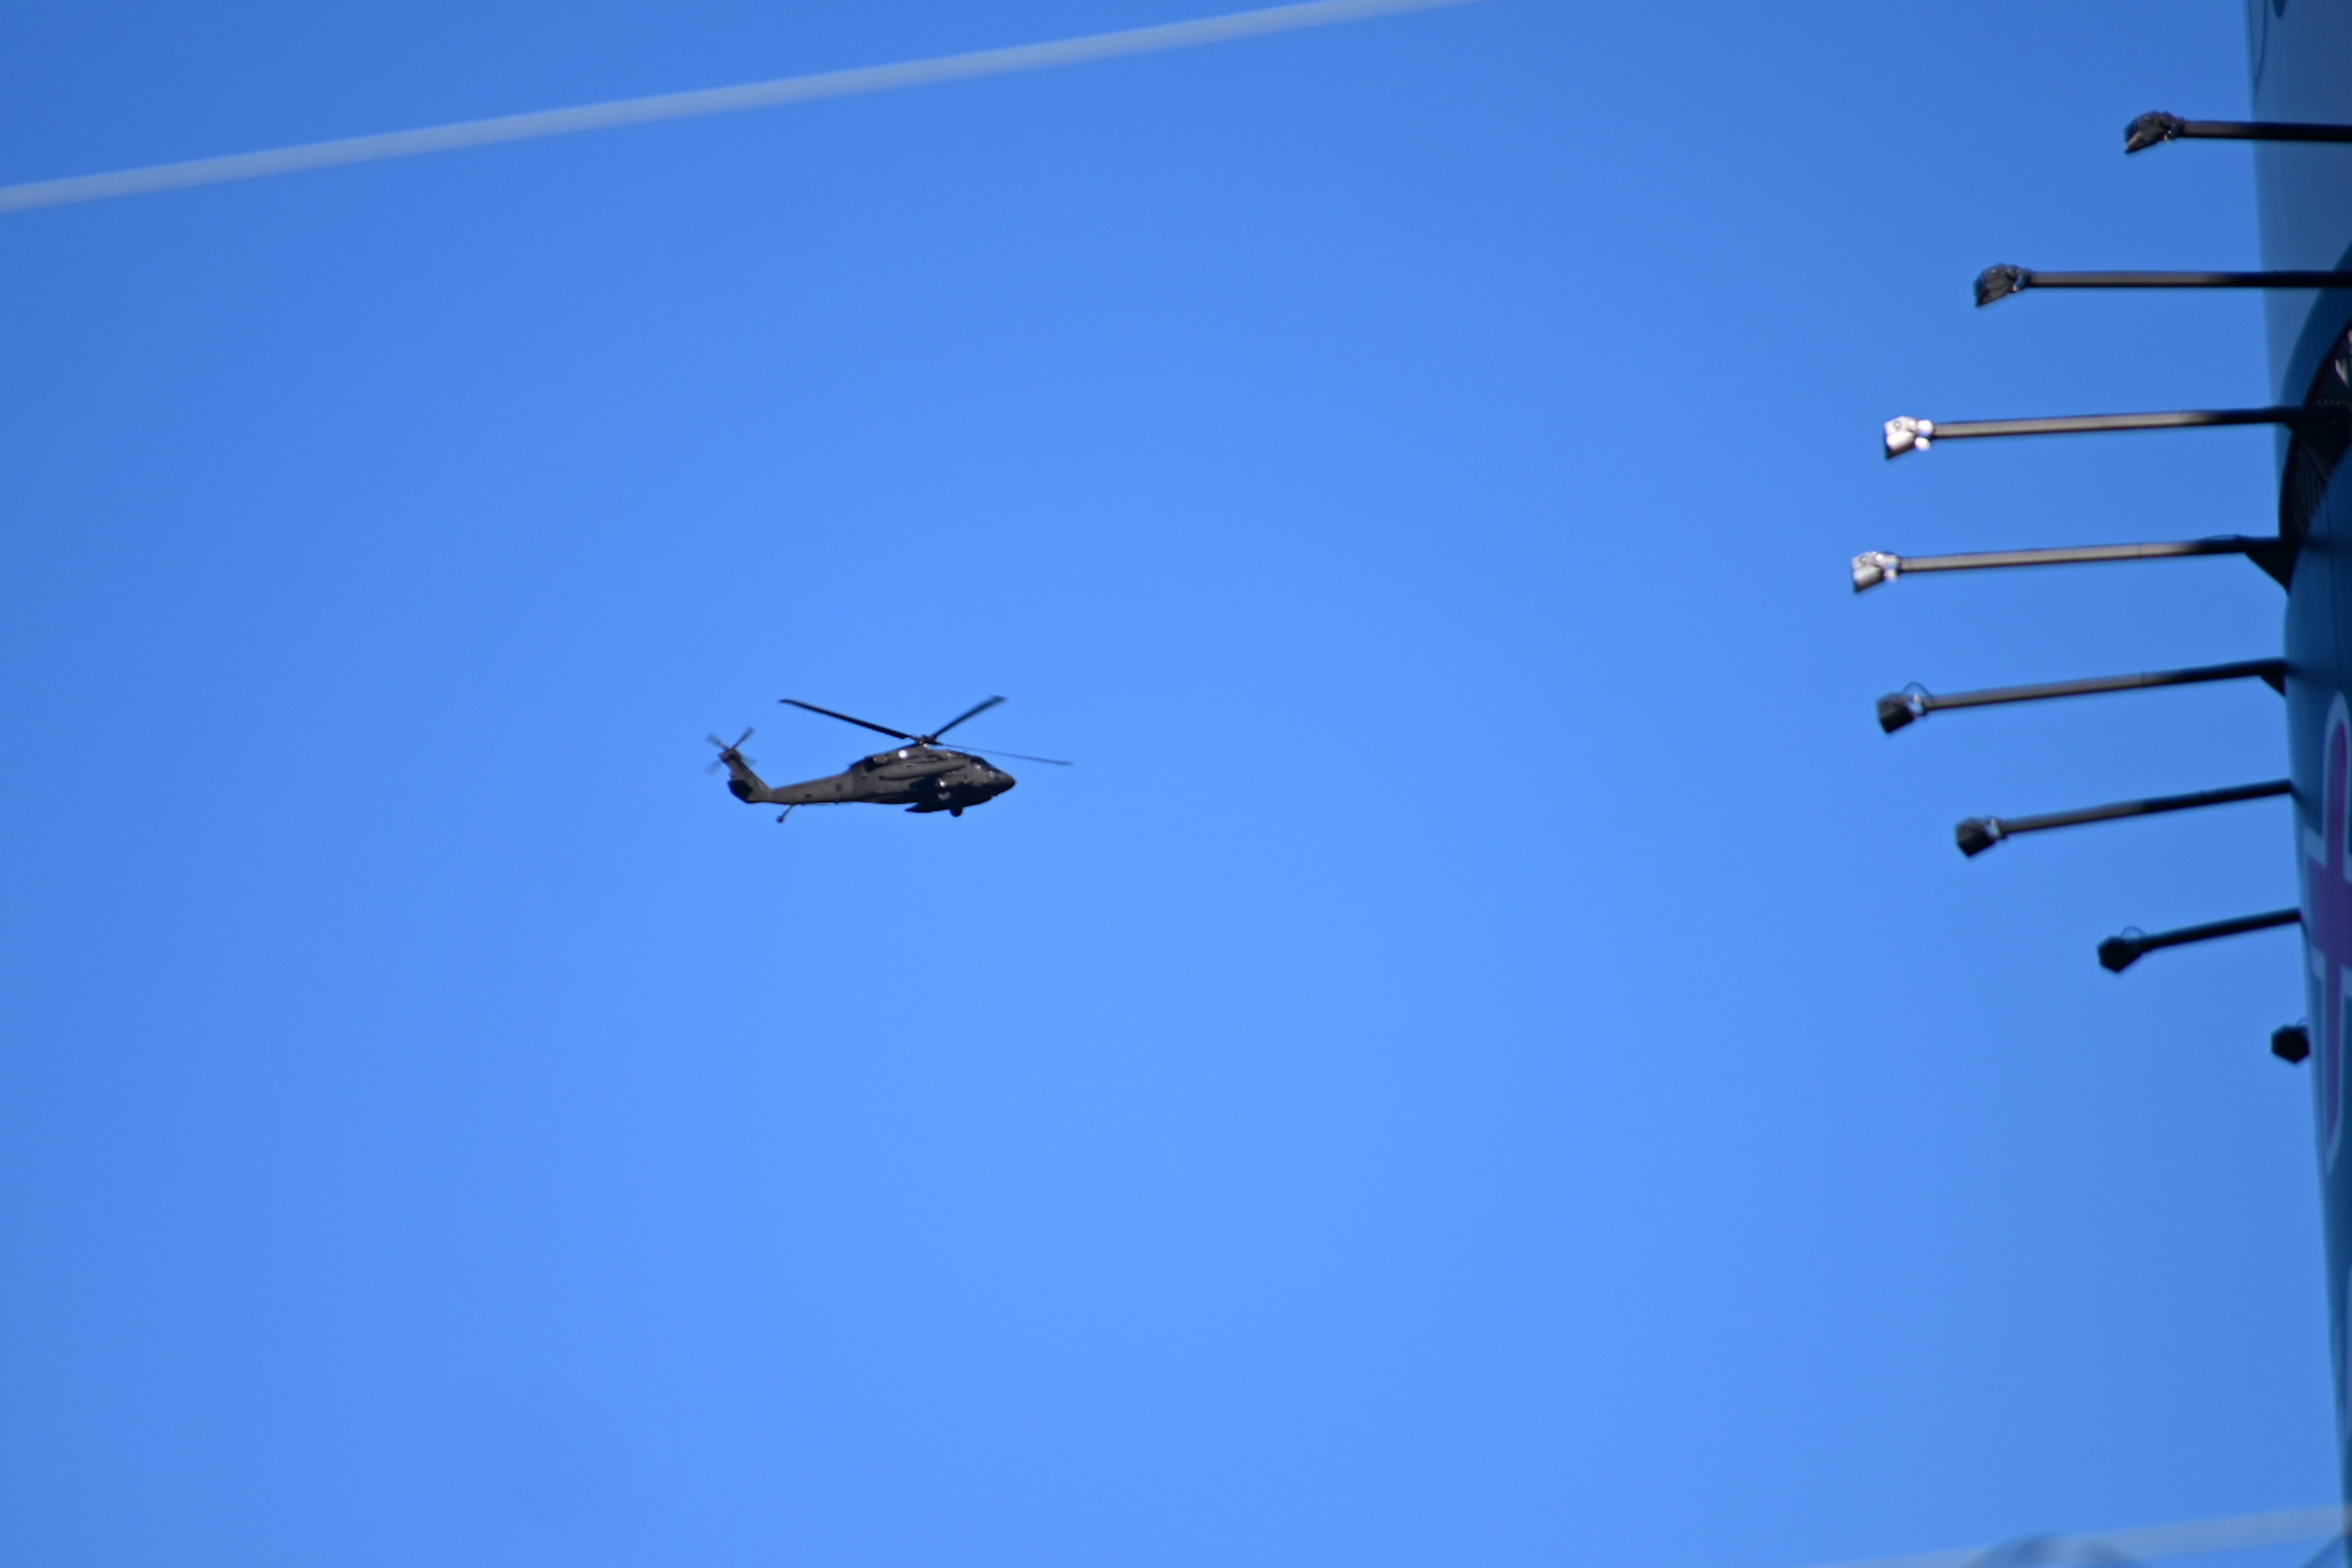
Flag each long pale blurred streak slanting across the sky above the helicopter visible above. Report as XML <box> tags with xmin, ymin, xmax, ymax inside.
<box><xmin>0</xmin><ymin>0</ymin><xmax>1475</xmax><ymax>214</ymax></box>
